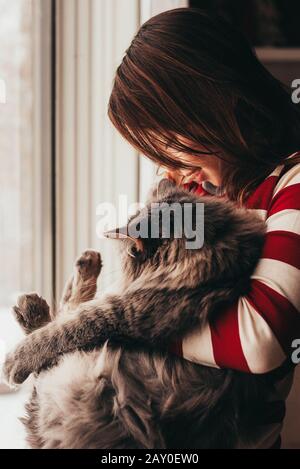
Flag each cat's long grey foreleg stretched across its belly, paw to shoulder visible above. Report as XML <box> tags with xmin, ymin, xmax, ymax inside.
<box><xmin>4</xmin><ymin>287</ymin><xmax>211</xmax><ymax>383</ymax></box>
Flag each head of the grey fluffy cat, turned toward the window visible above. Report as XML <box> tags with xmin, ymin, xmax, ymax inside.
<box><xmin>105</xmin><ymin>179</ymin><xmax>264</xmax><ymax>288</ymax></box>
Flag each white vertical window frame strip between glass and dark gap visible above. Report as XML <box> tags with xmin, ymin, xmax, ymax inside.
<box><xmin>28</xmin><ymin>0</ymin><xmax>53</xmax><ymax>302</ymax></box>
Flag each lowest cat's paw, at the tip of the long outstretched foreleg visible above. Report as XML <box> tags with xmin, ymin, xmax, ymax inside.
<box><xmin>2</xmin><ymin>347</ymin><xmax>32</xmax><ymax>388</ymax></box>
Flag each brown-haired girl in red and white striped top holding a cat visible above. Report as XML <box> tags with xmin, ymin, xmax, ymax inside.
<box><xmin>109</xmin><ymin>8</ymin><xmax>300</xmax><ymax>448</ymax></box>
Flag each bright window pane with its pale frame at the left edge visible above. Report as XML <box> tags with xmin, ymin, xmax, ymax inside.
<box><xmin>0</xmin><ymin>0</ymin><xmax>52</xmax><ymax>346</ymax></box>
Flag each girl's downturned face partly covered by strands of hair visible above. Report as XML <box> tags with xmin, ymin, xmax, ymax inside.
<box><xmin>162</xmin><ymin>137</ymin><xmax>223</xmax><ymax>186</ymax></box>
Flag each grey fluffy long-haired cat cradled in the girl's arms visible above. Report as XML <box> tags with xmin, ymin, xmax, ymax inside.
<box><xmin>4</xmin><ymin>180</ymin><xmax>271</xmax><ymax>449</ymax></box>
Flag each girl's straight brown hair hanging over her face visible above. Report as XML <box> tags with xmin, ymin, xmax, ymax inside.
<box><xmin>108</xmin><ymin>8</ymin><xmax>300</xmax><ymax>200</ymax></box>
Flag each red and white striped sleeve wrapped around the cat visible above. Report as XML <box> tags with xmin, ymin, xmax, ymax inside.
<box><xmin>181</xmin><ymin>165</ymin><xmax>300</xmax><ymax>373</ymax></box>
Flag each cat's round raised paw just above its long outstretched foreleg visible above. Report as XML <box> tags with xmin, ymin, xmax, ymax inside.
<box><xmin>13</xmin><ymin>293</ymin><xmax>51</xmax><ymax>334</ymax></box>
